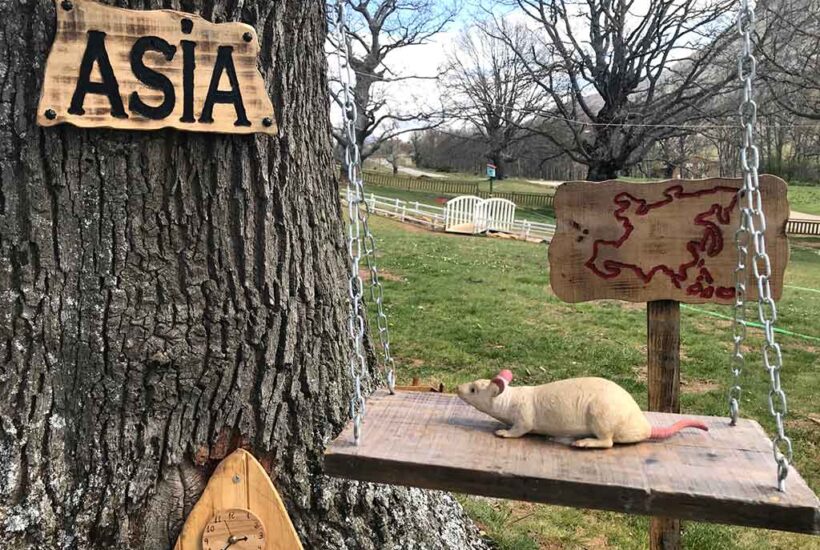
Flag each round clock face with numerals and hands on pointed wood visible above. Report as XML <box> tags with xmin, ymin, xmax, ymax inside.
<box><xmin>202</xmin><ymin>508</ymin><xmax>267</xmax><ymax>550</ymax></box>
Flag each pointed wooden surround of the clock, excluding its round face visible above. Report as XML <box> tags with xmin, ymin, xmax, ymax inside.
<box><xmin>174</xmin><ymin>449</ymin><xmax>302</xmax><ymax>550</ymax></box>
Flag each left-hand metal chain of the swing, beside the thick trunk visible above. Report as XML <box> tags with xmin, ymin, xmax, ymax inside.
<box><xmin>336</xmin><ymin>0</ymin><xmax>395</xmax><ymax>444</ymax></box>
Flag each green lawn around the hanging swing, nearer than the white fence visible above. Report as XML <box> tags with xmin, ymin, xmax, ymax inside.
<box><xmin>364</xmin><ymin>217</ymin><xmax>820</xmax><ymax>550</ymax></box>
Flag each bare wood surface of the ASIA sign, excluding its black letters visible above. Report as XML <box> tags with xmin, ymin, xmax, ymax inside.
<box><xmin>37</xmin><ymin>0</ymin><xmax>277</xmax><ymax>134</ymax></box>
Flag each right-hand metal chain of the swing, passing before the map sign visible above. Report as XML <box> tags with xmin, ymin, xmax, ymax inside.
<box><xmin>729</xmin><ymin>0</ymin><xmax>792</xmax><ymax>491</ymax></box>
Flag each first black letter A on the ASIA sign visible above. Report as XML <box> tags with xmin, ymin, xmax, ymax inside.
<box><xmin>68</xmin><ymin>31</ymin><xmax>128</xmax><ymax>118</ymax></box>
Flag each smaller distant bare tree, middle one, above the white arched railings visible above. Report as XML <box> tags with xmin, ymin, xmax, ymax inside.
<box><xmin>442</xmin><ymin>23</ymin><xmax>546</xmax><ymax>179</ymax></box>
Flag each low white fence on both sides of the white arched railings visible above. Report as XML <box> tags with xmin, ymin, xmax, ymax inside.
<box><xmin>343</xmin><ymin>193</ymin><xmax>555</xmax><ymax>241</ymax></box>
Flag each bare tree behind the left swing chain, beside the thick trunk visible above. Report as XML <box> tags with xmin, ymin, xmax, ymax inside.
<box><xmin>328</xmin><ymin>0</ymin><xmax>459</xmax><ymax>160</ymax></box>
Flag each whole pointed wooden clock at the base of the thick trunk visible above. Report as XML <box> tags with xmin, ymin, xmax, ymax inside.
<box><xmin>174</xmin><ymin>449</ymin><xmax>303</xmax><ymax>550</ymax></box>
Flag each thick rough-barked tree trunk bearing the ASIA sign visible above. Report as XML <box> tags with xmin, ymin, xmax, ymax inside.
<box><xmin>0</xmin><ymin>0</ymin><xmax>483</xmax><ymax>549</ymax></box>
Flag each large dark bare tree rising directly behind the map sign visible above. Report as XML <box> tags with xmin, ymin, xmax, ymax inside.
<box><xmin>494</xmin><ymin>0</ymin><xmax>735</xmax><ymax>181</ymax></box>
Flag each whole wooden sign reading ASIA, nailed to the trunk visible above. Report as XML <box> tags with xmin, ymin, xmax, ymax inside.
<box><xmin>37</xmin><ymin>0</ymin><xmax>276</xmax><ymax>134</ymax></box>
